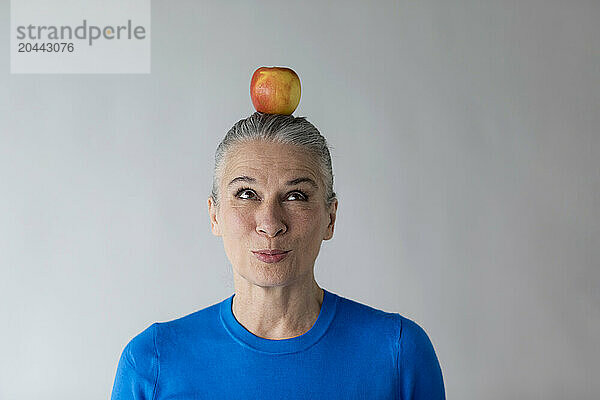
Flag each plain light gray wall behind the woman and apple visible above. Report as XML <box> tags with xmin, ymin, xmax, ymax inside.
<box><xmin>0</xmin><ymin>0</ymin><xmax>600</xmax><ymax>400</ymax></box>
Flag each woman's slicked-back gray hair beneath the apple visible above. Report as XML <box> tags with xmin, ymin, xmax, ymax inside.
<box><xmin>210</xmin><ymin>112</ymin><xmax>337</xmax><ymax>207</ymax></box>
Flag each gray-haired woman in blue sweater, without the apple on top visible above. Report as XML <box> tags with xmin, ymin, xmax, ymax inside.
<box><xmin>112</xmin><ymin>112</ymin><xmax>445</xmax><ymax>400</ymax></box>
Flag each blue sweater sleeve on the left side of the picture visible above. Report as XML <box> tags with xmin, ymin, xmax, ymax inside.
<box><xmin>111</xmin><ymin>323</ymin><xmax>159</xmax><ymax>400</ymax></box>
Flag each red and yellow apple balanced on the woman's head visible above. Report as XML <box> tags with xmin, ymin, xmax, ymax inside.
<box><xmin>250</xmin><ymin>67</ymin><xmax>300</xmax><ymax>115</ymax></box>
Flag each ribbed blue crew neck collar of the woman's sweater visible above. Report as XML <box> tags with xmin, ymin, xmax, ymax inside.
<box><xmin>219</xmin><ymin>289</ymin><xmax>338</xmax><ymax>354</ymax></box>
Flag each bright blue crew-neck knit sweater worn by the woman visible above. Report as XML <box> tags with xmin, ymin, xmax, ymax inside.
<box><xmin>111</xmin><ymin>290</ymin><xmax>445</xmax><ymax>400</ymax></box>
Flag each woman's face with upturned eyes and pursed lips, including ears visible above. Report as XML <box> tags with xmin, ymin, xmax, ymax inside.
<box><xmin>208</xmin><ymin>141</ymin><xmax>337</xmax><ymax>287</ymax></box>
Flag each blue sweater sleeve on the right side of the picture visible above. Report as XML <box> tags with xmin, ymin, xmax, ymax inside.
<box><xmin>398</xmin><ymin>316</ymin><xmax>446</xmax><ymax>400</ymax></box>
